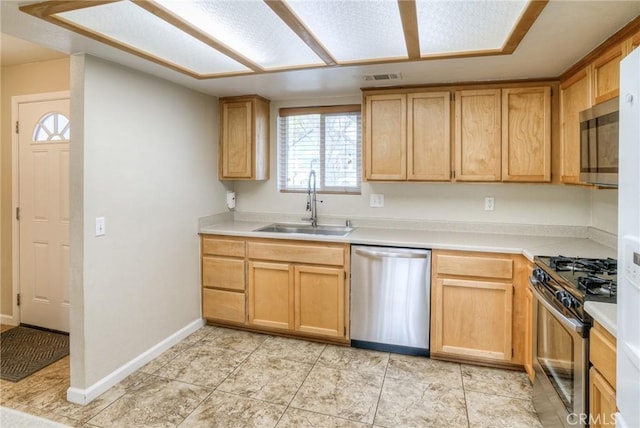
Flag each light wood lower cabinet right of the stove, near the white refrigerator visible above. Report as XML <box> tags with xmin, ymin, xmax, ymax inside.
<box><xmin>589</xmin><ymin>322</ymin><xmax>617</xmax><ymax>428</ymax></box>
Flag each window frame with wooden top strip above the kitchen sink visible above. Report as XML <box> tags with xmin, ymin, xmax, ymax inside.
<box><xmin>277</xmin><ymin>104</ymin><xmax>362</xmax><ymax>195</ymax></box>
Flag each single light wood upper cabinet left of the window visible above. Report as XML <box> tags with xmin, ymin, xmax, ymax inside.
<box><xmin>218</xmin><ymin>96</ymin><xmax>269</xmax><ymax>180</ymax></box>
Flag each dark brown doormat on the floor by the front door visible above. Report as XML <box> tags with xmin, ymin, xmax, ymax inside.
<box><xmin>0</xmin><ymin>326</ymin><xmax>69</xmax><ymax>382</ymax></box>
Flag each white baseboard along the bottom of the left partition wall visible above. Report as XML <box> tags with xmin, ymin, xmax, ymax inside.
<box><xmin>67</xmin><ymin>318</ymin><xmax>204</xmax><ymax>405</ymax></box>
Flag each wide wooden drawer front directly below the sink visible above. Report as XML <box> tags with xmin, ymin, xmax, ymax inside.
<box><xmin>247</xmin><ymin>242</ymin><xmax>344</xmax><ymax>266</ymax></box>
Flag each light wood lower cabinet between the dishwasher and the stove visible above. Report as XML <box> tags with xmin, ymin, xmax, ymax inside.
<box><xmin>431</xmin><ymin>250</ymin><xmax>532</xmax><ymax>367</ymax></box>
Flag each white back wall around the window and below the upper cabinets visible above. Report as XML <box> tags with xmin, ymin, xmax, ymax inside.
<box><xmin>235</xmin><ymin>97</ymin><xmax>591</xmax><ymax>231</ymax></box>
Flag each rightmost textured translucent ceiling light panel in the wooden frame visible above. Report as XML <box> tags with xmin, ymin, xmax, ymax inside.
<box><xmin>416</xmin><ymin>0</ymin><xmax>529</xmax><ymax>56</ymax></box>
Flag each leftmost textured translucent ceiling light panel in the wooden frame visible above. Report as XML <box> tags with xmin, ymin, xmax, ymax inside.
<box><xmin>56</xmin><ymin>1</ymin><xmax>249</xmax><ymax>74</ymax></box>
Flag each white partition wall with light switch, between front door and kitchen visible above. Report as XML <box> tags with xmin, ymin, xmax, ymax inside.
<box><xmin>71</xmin><ymin>55</ymin><xmax>226</xmax><ymax>389</ymax></box>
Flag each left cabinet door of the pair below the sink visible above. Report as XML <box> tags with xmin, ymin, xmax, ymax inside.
<box><xmin>248</xmin><ymin>261</ymin><xmax>294</xmax><ymax>330</ymax></box>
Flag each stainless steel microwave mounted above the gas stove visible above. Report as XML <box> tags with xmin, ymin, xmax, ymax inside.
<box><xmin>580</xmin><ymin>98</ymin><xmax>619</xmax><ymax>187</ymax></box>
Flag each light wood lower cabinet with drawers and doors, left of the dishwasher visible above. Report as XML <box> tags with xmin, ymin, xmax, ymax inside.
<box><xmin>202</xmin><ymin>235</ymin><xmax>350</xmax><ymax>343</ymax></box>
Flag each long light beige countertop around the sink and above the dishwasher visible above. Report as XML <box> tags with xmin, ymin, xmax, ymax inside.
<box><xmin>199</xmin><ymin>220</ymin><xmax>616</xmax><ymax>261</ymax></box>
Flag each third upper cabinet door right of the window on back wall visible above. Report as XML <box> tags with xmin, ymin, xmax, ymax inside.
<box><xmin>454</xmin><ymin>89</ymin><xmax>501</xmax><ymax>181</ymax></box>
